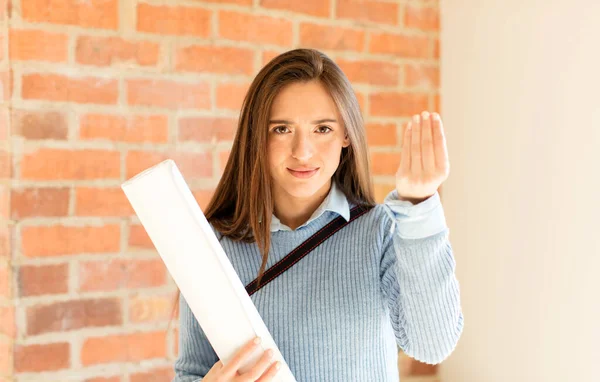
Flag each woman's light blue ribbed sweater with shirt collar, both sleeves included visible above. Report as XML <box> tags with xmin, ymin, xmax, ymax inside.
<box><xmin>174</xmin><ymin>182</ymin><xmax>463</xmax><ymax>382</ymax></box>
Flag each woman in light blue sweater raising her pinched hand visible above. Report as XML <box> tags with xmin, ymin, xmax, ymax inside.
<box><xmin>175</xmin><ymin>49</ymin><xmax>463</xmax><ymax>382</ymax></box>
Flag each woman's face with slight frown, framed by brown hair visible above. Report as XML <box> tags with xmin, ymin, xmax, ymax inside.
<box><xmin>267</xmin><ymin>81</ymin><xmax>350</xmax><ymax>199</ymax></box>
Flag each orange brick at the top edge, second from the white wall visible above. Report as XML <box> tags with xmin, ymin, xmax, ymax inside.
<box><xmin>336</xmin><ymin>0</ymin><xmax>398</xmax><ymax>25</ymax></box>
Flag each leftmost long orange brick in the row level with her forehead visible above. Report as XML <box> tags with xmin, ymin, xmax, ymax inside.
<box><xmin>22</xmin><ymin>74</ymin><xmax>119</xmax><ymax>104</ymax></box>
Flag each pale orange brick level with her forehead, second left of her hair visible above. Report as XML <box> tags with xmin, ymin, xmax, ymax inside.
<box><xmin>127</xmin><ymin>79</ymin><xmax>210</xmax><ymax>109</ymax></box>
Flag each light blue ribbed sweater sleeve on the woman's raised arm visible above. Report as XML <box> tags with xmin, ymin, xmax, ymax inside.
<box><xmin>380</xmin><ymin>190</ymin><xmax>464</xmax><ymax>364</ymax></box>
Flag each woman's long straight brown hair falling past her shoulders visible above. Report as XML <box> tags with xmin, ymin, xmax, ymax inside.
<box><xmin>169</xmin><ymin>49</ymin><xmax>375</xmax><ymax>328</ymax></box>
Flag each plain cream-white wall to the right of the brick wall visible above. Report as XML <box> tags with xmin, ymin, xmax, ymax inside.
<box><xmin>440</xmin><ymin>0</ymin><xmax>600</xmax><ymax>382</ymax></box>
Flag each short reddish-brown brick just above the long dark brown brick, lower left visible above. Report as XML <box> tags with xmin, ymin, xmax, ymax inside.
<box><xmin>18</xmin><ymin>264</ymin><xmax>69</xmax><ymax>297</ymax></box>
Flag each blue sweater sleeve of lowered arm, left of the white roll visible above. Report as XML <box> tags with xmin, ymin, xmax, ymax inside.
<box><xmin>172</xmin><ymin>294</ymin><xmax>219</xmax><ymax>382</ymax></box>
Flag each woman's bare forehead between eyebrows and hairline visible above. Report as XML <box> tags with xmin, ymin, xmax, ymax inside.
<box><xmin>270</xmin><ymin>81</ymin><xmax>337</xmax><ymax>121</ymax></box>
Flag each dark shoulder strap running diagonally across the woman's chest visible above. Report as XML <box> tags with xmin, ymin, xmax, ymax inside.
<box><xmin>246</xmin><ymin>205</ymin><xmax>373</xmax><ymax>296</ymax></box>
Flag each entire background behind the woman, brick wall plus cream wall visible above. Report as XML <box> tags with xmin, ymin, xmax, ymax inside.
<box><xmin>0</xmin><ymin>0</ymin><xmax>600</xmax><ymax>382</ymax></box>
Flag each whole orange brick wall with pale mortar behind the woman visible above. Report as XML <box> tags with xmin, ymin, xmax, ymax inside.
<box><xmin>0</xmin><ymin>0</ymin><xmax>439</xmax><ymax>382</ymax></box>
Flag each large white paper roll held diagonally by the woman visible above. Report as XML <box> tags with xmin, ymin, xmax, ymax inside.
<box><xmin>121</xmin><ymin>159</ymin><xmax>296</xmax><ymax>382</ymax></box>
